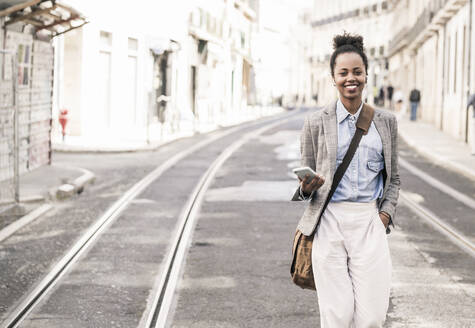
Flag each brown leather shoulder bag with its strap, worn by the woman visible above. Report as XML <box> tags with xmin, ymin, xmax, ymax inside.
<box><xmin>290</xmin><ymin>104</ymin><xmax>374</xmax><ymax>290</ymax></box>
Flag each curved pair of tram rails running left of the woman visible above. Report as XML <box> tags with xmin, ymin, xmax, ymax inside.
<box><xmin>1</xmin><ymin>113</ymin><xmax>304</xmax><ymax>328</ymax></box>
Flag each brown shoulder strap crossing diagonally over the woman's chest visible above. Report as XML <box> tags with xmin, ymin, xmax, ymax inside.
<box><xmin>319</xmin><ymin>104</ymin><xmax>374</xmax><ymax>222</ymax></box>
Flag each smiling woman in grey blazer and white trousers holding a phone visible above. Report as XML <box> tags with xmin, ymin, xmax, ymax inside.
<box><xmin>292</xmin><ymin>32</ymin><xmax>400</xmax><ymax>328</ymax></box>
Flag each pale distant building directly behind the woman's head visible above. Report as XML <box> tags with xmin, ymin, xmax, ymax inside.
<box><xmin>312</xmin><ymin>0</ymin><xmax>392</xmax><ymax>105</ymax></box>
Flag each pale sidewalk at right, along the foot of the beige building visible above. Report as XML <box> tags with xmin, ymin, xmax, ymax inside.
<box><xmin>398</xmin><ymin>116</ymin><xmax>475</xmax><ymax>181</ymax></box>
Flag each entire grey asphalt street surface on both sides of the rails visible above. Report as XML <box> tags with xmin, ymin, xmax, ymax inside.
<box><xmin>0</xmin><ymin>109</ymin><xmax>475</xmax><ymax>328</ymax></box>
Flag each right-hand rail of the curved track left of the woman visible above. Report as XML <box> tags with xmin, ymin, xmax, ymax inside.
<box><xmin>139</xmin><ymin>115</ymin><xmax>301</xmax><ymax>328</ymax></box>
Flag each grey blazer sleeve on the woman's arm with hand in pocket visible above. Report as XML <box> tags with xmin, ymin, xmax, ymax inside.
<box><xmin>380</xmin><ymin>116</ymin><xmax>401</xmax><ymax>221</ymax></box>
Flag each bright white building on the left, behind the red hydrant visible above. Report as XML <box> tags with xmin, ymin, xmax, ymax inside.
<box><xmin>55</xmin><ymin>0</ymin><xmax>193</xmax><ymax>142</ymax></box>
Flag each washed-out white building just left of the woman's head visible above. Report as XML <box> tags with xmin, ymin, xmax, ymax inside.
<box><xmin>252</xmin><ymin>0</ymin><xmax>314</xmax><ymax>107</ymax></box>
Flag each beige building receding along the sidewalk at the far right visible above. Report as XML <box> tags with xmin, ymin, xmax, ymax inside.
<box><xmin>388</xmin><ymin>0</ymin><xmax>474</xmax><ymax>143</ymax></box>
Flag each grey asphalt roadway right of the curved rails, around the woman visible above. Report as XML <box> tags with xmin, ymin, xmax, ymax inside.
<box><xmin>170</xmin><ymin>114</ymin><xmax>475</xmax><ymax>328</ymax></box>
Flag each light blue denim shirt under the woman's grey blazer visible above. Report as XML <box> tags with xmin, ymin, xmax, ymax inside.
<box><xmin>331</xmin><ymin>99</ymin><xmax>384</xmax><ymax>203</ymax></box>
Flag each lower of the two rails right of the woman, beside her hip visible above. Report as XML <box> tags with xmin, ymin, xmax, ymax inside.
<box><xmin>399</xmin><ymin>190</ymin><xmax>475</xmax><ymax>257</ymax></box>
